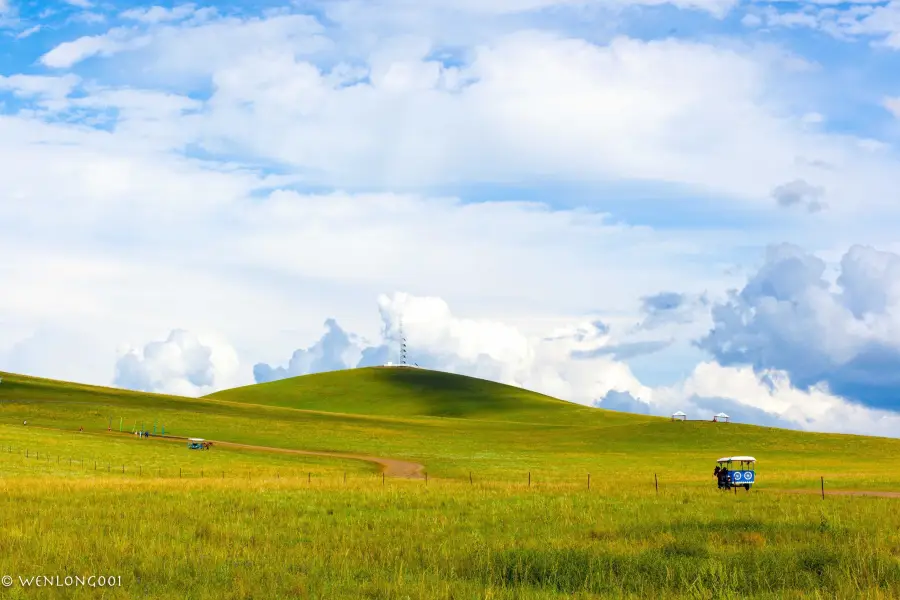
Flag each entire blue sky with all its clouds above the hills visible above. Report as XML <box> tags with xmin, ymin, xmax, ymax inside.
<box><xmin>0</xmin><ymin>0</ymin><xmax>900</xmax><ymax>437</ymax></box>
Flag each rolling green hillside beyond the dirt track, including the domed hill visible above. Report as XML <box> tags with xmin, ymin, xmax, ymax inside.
<box><xmin>0</xmin><ymin>368</ymin><xmax>900</xmax><ymax>489</ymax></box>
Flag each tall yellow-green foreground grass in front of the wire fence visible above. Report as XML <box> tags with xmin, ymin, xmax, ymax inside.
<box><xmin>0</xmin><ymin>477</ymin><xmax>900</xmax><ymax>599</ymax></box>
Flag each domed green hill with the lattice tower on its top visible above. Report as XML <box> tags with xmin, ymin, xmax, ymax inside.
<box><xmin>207</xmin><ymin>367</ymin><xmax>653</xmax><ymax>425</ymax></box>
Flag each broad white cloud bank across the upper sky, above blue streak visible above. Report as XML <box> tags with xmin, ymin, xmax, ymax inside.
<box><xmin>33</xmin><ymin>15</ymin><xmax>884</xmax><ymax>218</ymax></box>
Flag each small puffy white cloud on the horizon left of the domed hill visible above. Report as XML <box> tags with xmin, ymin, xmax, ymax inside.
<box><xmin>113</xmin><ymin>329</ymin><xmax>239</xmax><ymax>396</ymax></box>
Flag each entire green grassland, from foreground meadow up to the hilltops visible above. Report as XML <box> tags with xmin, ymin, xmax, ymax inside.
<box><xmin>0</xmin><ymin>369</ymin><xmax>900</xmax><ymax>598</ymax></box>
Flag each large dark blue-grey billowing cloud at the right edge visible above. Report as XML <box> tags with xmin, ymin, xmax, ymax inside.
<box><xmin>700</xmin><ymin>244</ymin><xmax>900</xmax><ymax>408</ymax></box>
